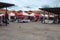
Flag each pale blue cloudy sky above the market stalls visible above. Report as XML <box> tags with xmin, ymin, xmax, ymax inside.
<box><xmin>0</xmin><ymin>0</ymin><xmax>60</xmax><ymax>10</ymax></box>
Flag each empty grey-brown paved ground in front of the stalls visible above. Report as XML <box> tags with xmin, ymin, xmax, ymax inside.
<box><xmin>0</xmin><ymin>22</ymin><xmax>60</xmax><ymax>40</ymax></box>
